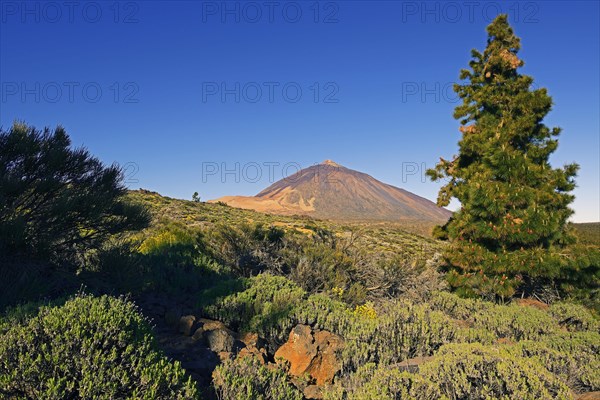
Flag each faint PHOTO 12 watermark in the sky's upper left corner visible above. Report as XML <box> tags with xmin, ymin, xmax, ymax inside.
<box><xmin>0</xmin><ymin>1</ymin><xmax>140</xmax><ymax>24</ymax></box>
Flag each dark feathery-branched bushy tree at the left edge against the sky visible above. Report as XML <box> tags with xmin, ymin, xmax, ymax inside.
<box><xmin>0</xmin><ymin>123</ymin><xmax>150</xmax><ymax>261</ymax></box>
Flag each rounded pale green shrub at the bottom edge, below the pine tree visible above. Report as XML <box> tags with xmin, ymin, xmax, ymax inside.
<box><xmin>419</xmin><ymin>343</ymin><xmax>571</xmax><ymax>400</ymax></box>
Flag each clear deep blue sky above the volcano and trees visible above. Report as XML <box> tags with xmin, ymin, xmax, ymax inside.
<box><xmin>0</xmin><ymin>0</ymin><xmax>600</xmax><ymax>221</ymax></box>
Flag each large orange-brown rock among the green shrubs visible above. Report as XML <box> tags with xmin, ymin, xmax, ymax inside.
<box><xmin>275</xmin><ymin>325</ymin><xmax>343</xmax><ymax>386</ymax></box>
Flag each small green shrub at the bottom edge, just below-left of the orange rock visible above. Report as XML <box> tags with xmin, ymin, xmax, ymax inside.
<box><xmin>213</xmin><ymin>357</ymin><xmax>304</xmax><ymax>400</ymax></box>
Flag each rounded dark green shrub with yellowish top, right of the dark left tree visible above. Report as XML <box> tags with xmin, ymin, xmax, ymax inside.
<box><xmin>86</xmin><ymin>221</ymin><xmax>228</xmax><ymax>296</ymax></box>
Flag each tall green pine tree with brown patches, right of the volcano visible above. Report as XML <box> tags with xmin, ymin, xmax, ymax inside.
<box><xmin>428</xmin><ymin>15</ymin><xmax>579</xmax><ymax>296</ymax></box>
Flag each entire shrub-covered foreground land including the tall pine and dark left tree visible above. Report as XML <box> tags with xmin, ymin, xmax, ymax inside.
<box><xmin>0</xmin><ymin>16</ymin><xmax>600</xmax><ymax>400</ymax></box>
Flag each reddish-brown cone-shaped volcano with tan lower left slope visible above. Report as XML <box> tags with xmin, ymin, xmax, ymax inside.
<box><xmin>214</xmin><ymin>160</ymin><xmax>452</xmax><ymax>223</ymax></box>
